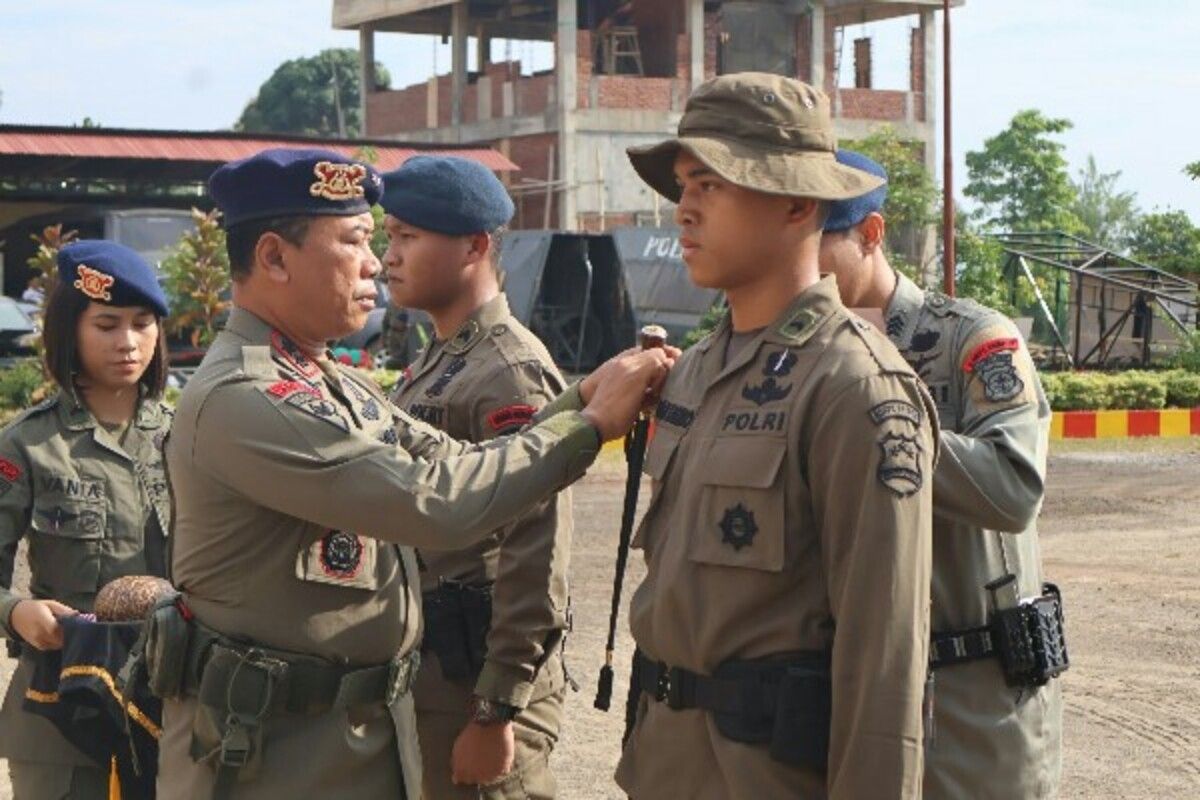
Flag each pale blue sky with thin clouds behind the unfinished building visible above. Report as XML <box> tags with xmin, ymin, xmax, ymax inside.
<box><xmin>0</xmin><ymin>0</ymin><xmax>1200</xmax><ymax>222</ymax></box>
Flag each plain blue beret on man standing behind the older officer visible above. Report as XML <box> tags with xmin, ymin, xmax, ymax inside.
<box><xmin>379</xmin><ymin>156</ymin><xmax>515</xmax><ymax>236</ymax></box>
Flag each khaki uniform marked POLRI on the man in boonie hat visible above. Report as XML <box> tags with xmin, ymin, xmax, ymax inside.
<box><xmin>617</xmin><ymin>277</ymin><xmax>937</xmax><ymax>800</ymax></box>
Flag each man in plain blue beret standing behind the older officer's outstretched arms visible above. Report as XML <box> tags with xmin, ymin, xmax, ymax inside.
<box><xmin>379</xmin><ymin>156</ymin><xmax>572</xmax><ymax>800</ymax></box>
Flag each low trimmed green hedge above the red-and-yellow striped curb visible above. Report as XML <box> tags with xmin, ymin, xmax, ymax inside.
<box><xmin>1042</xmin><ymin>369</ymin><xmax>1200</xmax><ymax>411</ymax></box>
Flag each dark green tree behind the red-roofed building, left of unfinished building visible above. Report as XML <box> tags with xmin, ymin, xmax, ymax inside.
<box><xmin>234</xmin><ymin>48</ymin><xmax>391</xmax><ymax>137</ymax></box>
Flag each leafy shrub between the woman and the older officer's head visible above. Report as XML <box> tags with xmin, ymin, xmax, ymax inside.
<box><xmin>162</xmin><ymin>209</ymin><xmax>229</xmax><ymax>347</ymax></box>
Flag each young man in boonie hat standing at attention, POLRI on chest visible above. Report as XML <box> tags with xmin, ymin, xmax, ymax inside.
<box><xmin>617</xmin><ymin>73</ymin><xmax>936</xmax><ymax>800</ymax></box>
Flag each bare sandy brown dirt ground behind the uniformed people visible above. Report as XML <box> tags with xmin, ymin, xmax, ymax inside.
<box><xmin>0</xmin><ymin>439</ymin><xmax>1200</xmax><ymax>800</ymax></box>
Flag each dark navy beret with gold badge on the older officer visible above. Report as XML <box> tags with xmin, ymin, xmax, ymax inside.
<box><xmin>209</xmin><ymin>148</ymin><xmax>383</xmax><ymax>228</ymax></box>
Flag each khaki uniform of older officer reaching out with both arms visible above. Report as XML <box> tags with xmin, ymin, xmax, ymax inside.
<box><xmin>158</xmin><ymin>308</ymin><xmax>598</xmax><ymax>800</ymax></box>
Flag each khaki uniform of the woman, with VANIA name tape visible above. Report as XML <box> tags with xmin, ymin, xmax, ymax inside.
<box><xmin>0</xmin><ymin>393</ymin><xmax>170</xmax><ymax>766</ymax></box>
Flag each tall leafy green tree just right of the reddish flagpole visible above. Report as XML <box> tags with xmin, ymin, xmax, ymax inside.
<box><xmin>962</xmin><ymin>109</ymin><xmax>1082</xmax><ymax>233</ymax></box>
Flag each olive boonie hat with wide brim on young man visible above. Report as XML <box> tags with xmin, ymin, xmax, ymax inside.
<box><xmin>628</xmin><ymin>72</ymin><xmax>883</xmax><ymax>203</ymax></box>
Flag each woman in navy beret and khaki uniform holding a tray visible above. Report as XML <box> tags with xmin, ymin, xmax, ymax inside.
<box><xmin>0</xmin><ymin>241</ymin><xmax>170</xmax><ymax>800</ymax></box>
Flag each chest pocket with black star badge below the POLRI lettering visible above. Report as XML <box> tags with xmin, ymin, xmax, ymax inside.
<box><xmin>688</xmin><ymin>437</ymin><xmax>787</xmax><ymax>572</ymax></box>
